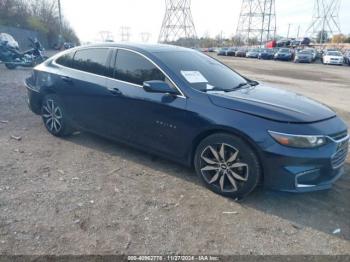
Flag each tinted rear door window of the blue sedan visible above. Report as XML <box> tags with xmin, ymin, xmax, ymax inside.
<box><xmin>73</xmin><ymin>48</ymin><xmax>108</xmax><ymax>76</ymax></box>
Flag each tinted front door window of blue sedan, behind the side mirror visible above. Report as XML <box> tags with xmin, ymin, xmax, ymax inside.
<box><xmin>115</xmin><ymin>50</ymin><xmax>166</xmax><ymax>85</ymax></box>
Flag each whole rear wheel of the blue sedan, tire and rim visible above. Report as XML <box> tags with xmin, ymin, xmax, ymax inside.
<box><xmin>41</xmin><ymin>95</ymin><xmax>74</xmax><ymax>137</ymax></box>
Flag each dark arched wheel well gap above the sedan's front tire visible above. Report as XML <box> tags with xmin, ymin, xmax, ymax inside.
<box><xmin>190</xmin><ymin>128</ymin><xmax>264</xmax><ymax>180</ymax></box>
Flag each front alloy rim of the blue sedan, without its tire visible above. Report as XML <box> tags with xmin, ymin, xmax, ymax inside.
<box><xmin>200</xmin><ymin>143</ymin><xmax>249</xmax><ymax>193</ymax></box>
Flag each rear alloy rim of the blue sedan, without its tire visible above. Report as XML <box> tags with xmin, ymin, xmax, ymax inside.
<box><xmin>42</xmin><ymin>99</ymin><xmax>62</xmax><ymax>134</ymax></box>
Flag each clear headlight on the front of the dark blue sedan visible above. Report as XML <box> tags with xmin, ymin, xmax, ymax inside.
<box><xmin>269</xmin><ymin>131</ymin><xmax>327</xmax><ymax>148</ymax></box>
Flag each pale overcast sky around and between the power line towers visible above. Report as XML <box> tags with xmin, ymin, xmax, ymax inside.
<box><xmin>61</xmin><ymin>0</ymin><xmax>350</xmax><ymax>42</ymax></box>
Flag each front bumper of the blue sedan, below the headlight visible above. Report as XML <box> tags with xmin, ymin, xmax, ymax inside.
<box><xmin>263</xmin><ymin>135</ymin><xmax>349</xmax><ymax>192</ymax></box>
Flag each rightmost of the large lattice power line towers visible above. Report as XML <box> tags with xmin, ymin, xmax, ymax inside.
<box><xmin>306</xmin><ymin>0</ymin><xmax>341</xmax><ymax>43</ymax></box>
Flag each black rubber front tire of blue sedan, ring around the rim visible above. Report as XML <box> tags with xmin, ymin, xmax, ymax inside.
<box><xmin>194</xmin><ymin>133</ymin><xmax>261</xmax><ymax>199</ymax></box>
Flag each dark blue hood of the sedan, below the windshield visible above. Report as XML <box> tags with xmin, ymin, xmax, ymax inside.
<box><xmin>209</xmin><ymin>85</ymin><xmax>336</xmax><ymax>123</ymax></box>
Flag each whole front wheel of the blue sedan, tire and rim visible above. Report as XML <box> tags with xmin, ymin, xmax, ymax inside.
<box><xmin>194</xmin><ymin>133</ymin><xmax>262</xmax><ymax>199</ymax></box>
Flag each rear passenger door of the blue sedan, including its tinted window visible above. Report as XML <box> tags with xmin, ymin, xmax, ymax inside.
<box><xmin>57</xmin><ymin>48</ymin><xmax>112</xmax><ymax>135</ymax></box>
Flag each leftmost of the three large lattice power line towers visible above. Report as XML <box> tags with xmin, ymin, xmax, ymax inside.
<box><xmin>158</xmin><ymin>0</ymin><xmax>197</xmax><ymax>43</ymax></box>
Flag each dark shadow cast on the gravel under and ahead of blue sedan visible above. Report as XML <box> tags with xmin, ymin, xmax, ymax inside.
<box><xmin>67</xmin><ymin>133</ymin><xmax>350</xmax><ymax>240</ymax></box>
